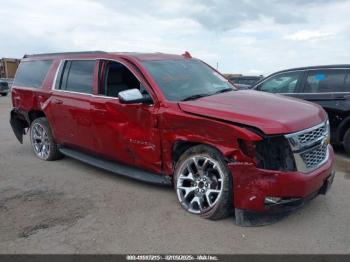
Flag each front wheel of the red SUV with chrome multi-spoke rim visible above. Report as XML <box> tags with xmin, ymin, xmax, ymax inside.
<box><xmin>174</xmin><ymin>145</ymin><xmax>233</xmax><ymax>220</ymax></box>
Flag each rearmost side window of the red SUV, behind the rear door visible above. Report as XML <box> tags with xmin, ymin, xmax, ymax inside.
<box><xmin>13</xmin><ymin>60</ymin><xmax>52</xmax><ymax>88</ymax></box>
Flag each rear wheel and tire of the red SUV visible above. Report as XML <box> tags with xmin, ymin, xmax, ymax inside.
<box><xmin>30</xmin><ymin>117</ymin><xmax>63</xmax><ymax>161</ymax></box>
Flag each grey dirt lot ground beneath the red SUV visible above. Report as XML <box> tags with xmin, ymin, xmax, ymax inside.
<box><xmin>0</xmin><ymin>94</ymin><xmax>350</xmax><ymax>254</ymax></box>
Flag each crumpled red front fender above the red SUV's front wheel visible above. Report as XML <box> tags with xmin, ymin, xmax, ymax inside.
<box><xmin>160</xmin><ymin>103</ymin><xmax>262</xmax><ymax>175</ymax></box>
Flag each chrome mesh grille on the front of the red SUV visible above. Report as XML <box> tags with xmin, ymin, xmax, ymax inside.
<box><xmin>285</xmin><ymin>121</ymin><xmax>329</xmax><ymax>173</ymax></box>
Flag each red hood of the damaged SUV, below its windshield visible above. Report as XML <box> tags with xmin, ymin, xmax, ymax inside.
<box><xmin>179</xmin><ymin>90</ymin><xmax>327</xmax><ymax>134</ymax></box>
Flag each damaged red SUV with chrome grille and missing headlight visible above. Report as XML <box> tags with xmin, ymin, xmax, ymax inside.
<box><xmin>10</xmin><ymin>52</ymin><xmax>334</xmax><ymax>225</ymax></box>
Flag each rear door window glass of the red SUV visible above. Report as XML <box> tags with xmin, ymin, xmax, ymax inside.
<box><xmin>56</xmin><ymin>60</ymin><xmax>96</xmax><ymax>94</ymax></box>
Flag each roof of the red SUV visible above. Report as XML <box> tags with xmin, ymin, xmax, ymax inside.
<box><xmin>23</xmin><ymin>51</ymin><xmax>185</xmax><ymax>61</ymax></box>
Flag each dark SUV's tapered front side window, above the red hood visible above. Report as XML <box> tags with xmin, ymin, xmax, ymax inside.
<box><xmin>258</xmin><ymin>72</ymin><xmax>302</xmax><ymax>93</ymax></box>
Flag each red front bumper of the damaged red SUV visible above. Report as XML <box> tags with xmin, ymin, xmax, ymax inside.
<box><xmin>229</xmin><ymin>145</ymin><xmax>334</xmax><ymax>212</ymax></box>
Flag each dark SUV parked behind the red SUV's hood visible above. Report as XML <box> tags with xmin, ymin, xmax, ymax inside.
<box><xmin>252</xmin><ymin>65</ymin><xmax>350</xmax><ymax>154</ymax></box>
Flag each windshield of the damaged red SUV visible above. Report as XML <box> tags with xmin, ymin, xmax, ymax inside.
<box><xmin>142</xmin><ymin>60</ymin><xmax>235</xmax><ymax>101</ymax></box>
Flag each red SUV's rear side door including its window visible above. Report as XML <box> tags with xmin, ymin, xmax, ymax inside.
<box><xmin>48</xmin><ymin>60</ymin><xmax>96</xmax><ymax>151</ymax></box>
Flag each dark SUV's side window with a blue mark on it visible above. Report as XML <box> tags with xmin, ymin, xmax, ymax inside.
<box><xmin>304</xmin><ymin>70</ymin><xmax>346</xmax><ymax>93</ymax></box>
